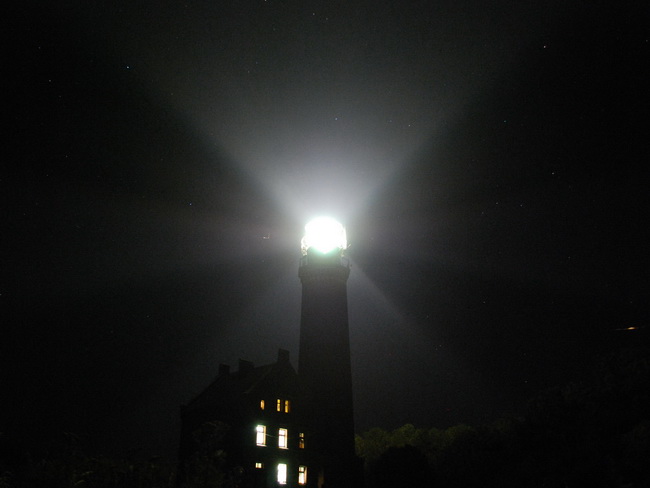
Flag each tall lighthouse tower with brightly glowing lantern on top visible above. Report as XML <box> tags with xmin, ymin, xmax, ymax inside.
<box><xmin>298</xmin><ymin>218</ymin><xmax>359</xmax><ymax>488</ymax></box>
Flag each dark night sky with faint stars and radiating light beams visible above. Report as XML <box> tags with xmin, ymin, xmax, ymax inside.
<box><xmin>5</xmin><ymin>0</ymin><xmax>650</xmax><ymax>455</ymax></box>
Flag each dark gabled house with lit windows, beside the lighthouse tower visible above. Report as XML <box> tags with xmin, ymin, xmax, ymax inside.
<box><xmin>179</xmin><ymin>349</ymin><xmax>315</xmax><ymax>488</ymax></box>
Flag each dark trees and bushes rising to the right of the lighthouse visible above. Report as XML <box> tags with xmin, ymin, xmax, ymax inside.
<box><xmin>356</xmin><ymin>350</ymin><xmax>650</xmax><ymax>488</ymax></box>
